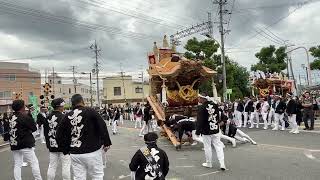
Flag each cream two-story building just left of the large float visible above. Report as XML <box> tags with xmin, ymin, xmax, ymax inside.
<box><xmin>102</xmin><ymin>76</ymin><xmax>150</xmax><ymax>104</ymax></box>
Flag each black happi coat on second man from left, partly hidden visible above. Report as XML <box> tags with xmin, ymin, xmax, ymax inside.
<box><xmin>43</xmin><ymin>111</ymin><xmax>64</xmax><ymax>152</ymax></box>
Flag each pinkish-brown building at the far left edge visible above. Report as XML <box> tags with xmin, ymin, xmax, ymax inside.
<box><xmin>0</xmin><ymin>62</ymin><xmax>41</xmax><ymax>112</ymax></box>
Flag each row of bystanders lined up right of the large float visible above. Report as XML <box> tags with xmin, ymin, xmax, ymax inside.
<box><xmin>228</xmin><ymin>91</ymin><xmax>318</xmax><ymax>134</ymax></box>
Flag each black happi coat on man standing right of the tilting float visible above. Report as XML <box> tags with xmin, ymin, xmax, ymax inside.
<box><xmin>196</xmin><ymin>101</ymin><xmax>225</xmax><ymax>135</ymax></box>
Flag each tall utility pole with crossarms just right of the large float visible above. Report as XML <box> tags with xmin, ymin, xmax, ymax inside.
<box><xmin>214</xmin><ymin>0</ymin><xmax>229</xmax><ymax>101</ymax></box>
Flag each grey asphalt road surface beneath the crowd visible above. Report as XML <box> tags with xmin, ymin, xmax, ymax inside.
<box><xmin>0</xmin><ymin>121</ymin><xmax>320</xmax><ymax>180</ymax></box>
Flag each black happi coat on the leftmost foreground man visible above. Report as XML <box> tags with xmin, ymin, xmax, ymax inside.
<box><xmin>9</xmin><ymin>112</ymin><xmax>37</xmax><ymax>151</ymax></box>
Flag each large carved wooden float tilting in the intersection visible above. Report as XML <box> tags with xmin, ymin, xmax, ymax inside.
<box><xmin>147</xmin><ymin>36</ymin><xmax>216</xmax><ymax>148</ymax></box>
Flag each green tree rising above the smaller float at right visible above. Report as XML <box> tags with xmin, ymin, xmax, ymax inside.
<box><xmin>251</xmin><ymin>45</ymin><xmax>287</xmax><ymax>73</ymax></box>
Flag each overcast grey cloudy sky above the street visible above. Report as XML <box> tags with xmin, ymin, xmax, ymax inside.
<box><xmin>0</xmin><ymin>0</ymin><xmax>320</xmax><ymax>84</ymax></box>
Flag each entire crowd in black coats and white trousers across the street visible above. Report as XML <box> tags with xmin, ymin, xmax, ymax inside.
<box><xmin>0</xmin><ymin>92</ymin><xmax>317</xmax><ymax>180</ymax></box>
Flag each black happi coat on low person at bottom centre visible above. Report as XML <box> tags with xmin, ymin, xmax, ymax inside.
<box><xmin>129</xmin><ymin>144</ymin><xmax>169</xmax><ymax>180</ymax></box>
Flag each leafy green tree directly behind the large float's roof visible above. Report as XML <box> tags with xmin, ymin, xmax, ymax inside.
<box><xmin>184</xmin><ymin>38</ymin><xmax>250</xmax><ymax>99</ymax></box>
